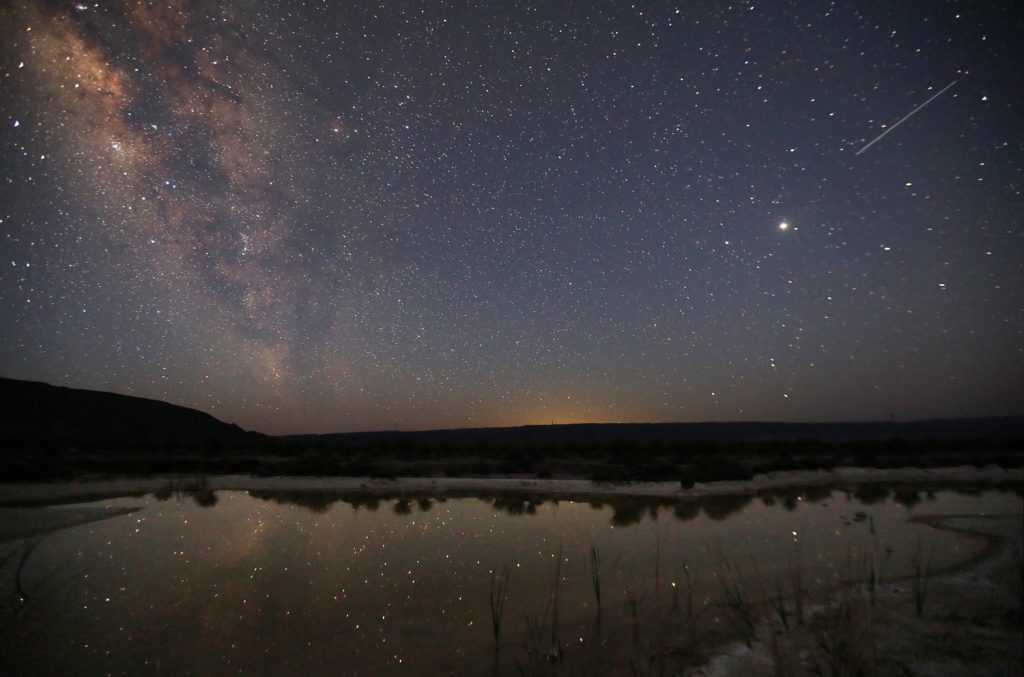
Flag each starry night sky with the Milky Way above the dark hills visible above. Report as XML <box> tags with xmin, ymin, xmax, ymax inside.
<box><xmin>0</xmin><ymin>0</ymin><xmax>1024</xmax><ymax>433</ymax></box>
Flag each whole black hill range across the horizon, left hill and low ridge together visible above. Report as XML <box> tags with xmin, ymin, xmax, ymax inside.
<box><xmin>0</xmin><ymin>378</ymin><xmax>1024</xmax><ymax>450</ymax></box>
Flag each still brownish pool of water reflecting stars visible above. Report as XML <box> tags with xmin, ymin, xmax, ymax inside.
<box><xmin>0</xmin><ymin>486</ymin><xmax>1022</xmax><ymax>676</ymax></box>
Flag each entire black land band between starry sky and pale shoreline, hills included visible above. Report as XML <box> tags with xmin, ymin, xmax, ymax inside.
<box><xmin>0</xmin><ymin>379</ymin><xmax>1024</xmax><ymax>481</ymax></box>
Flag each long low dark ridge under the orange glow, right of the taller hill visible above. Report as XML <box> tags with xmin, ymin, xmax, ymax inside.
<box><xmin>286</xmin><ymin>416</ymin><xmax>1024</xmax><ymax>447</ymax></box>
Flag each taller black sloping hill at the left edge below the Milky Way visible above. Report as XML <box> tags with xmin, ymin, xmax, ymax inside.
<box><xmin>0</xmin><ymin>378</ymin><xmax>265</xmax><ymax>450</ymax></box>
